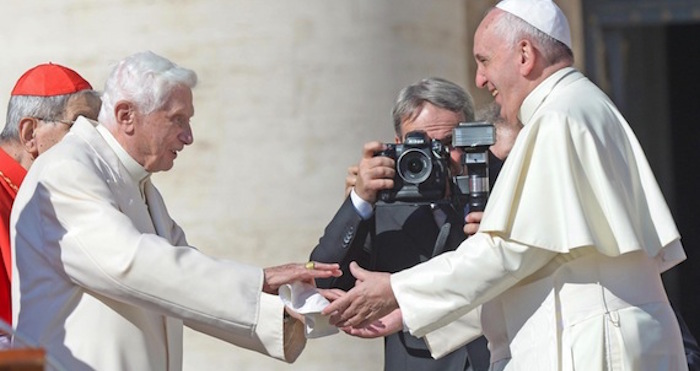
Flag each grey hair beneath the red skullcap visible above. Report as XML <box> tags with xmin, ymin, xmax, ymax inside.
<box><xmin>0</xmin><ymin>90</ymin><xmax>99</xmax><ymax>142</ymax></box>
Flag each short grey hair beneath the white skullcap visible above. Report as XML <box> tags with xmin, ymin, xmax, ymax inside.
<box><xmin>493</xmin><ymin>8</ymin><xmax>574</xmax><ymax>65</ymax></box>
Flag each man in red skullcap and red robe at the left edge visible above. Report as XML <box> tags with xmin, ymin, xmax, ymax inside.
<box><xmin>0</xmin><ymin>63</ymin><xmax>100</xmax><ymax>349</ymax></box>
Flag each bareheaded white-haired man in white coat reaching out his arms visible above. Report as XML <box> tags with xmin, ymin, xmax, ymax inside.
<box><xmin>10</xmin><ymin>52</ymin><xmax>340</xmax><ymax>371</ymax></box>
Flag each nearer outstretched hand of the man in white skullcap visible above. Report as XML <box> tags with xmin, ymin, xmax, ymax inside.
<box><xmin>322</xmin><ymin>262</ymin><xmax>399</xmax><ymax>328</ymax></box>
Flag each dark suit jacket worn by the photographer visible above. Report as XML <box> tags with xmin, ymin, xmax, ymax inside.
<box><xmin>311</xmin><ymin>155</ymin><xmax>502</xmax><ymax>371</ymax></box>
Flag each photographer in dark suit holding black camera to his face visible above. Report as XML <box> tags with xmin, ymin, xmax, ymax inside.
<box><xmin>311</xmin><ymin>78</ymin><xmax>489</xmax><ymax>371</ymax></box>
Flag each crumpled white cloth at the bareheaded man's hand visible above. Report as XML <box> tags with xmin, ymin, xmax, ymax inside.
<box><xmin>279</xmin><ymin>282</ymin><xmax>338</xmax><ymax>339</ymax></box>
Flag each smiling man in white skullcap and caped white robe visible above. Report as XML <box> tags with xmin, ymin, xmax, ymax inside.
<box><xmin>324</xmin><ymin>0</ymin><xmax>688</xmax><ymax>371</ymax></box>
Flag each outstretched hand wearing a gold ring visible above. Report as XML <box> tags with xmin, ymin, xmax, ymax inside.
<box><xmin>263</xmin><ymin>262</ymin><xmax>343</xmax><ymax>295</ymax></box>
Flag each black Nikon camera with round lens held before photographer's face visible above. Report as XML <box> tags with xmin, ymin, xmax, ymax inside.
<box><xmin>375</xmin><ymin>131</ymin><xmax>449</xmax><ymax>202</ymax></box>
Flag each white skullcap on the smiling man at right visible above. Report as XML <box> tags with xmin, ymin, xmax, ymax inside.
<box><xmin>496</xmin><ymin>0</ymin><xmax>571</xmax><ymax>49</ymax></box>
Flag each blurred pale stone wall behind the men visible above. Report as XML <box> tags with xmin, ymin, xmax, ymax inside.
<box><xmin>0</xmin><ymin>0</ymin><xmax>578</xmax><ymax>371</ymax></box>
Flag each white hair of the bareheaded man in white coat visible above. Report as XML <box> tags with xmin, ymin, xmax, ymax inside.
<box><xmin>98</xmin><ymin>51</ymin><xmax>197</xmax><ymax>124</ymax></box>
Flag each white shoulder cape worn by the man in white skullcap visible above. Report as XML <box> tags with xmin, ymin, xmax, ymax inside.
<box><xmin>479</xmin><ymin>68</ymin><xmax>685</xmax><ymax>268</ymax></box>
